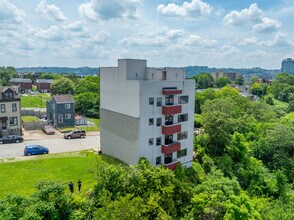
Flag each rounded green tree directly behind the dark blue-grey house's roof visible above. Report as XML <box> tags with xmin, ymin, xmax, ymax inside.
<box><xmin>51</xmin><ymin>77</ymin><xmax>74</xmax><ymax>95</ymax></box>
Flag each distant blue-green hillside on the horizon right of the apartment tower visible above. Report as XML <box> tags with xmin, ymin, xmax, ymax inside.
<box><xmin>185</xmin><ymin>66</ymin><xmax>281</xmax><ymax>79</ymax></box>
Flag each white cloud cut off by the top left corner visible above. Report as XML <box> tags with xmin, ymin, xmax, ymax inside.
<box><xmin>0</xmin><ymin>0</ymin><xmax>27</xmax><ymax>26</ymax></box>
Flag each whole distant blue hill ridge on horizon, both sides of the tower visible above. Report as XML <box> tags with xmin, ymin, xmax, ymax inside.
<box><xmin>16</xmin><ymin>66</ymin><xmax>281</xmax><ymax>79</ymax></box>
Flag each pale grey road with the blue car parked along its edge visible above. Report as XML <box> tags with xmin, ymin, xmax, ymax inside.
<box><xmin>0</xmin><ymin>135</ymin><xmax>100</xmax><ymax>159</ymax></box>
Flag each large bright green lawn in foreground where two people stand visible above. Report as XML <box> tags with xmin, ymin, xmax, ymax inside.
<box><xmin>0</xmin><ymin>151</ymin><xmax>122</xmax><ymax>199</ymax></box>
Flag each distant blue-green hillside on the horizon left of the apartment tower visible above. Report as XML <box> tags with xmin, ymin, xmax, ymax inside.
<box><xmin>16</xmin><ymin>67</ymin><xmax>99</xmax><ymax>75</ymax></box>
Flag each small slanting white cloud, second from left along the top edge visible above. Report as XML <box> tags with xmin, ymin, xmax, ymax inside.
<box><xmin>36</xmin><ymin>0</ymin><xmax>67</xmax><ymax>21</ymax></box>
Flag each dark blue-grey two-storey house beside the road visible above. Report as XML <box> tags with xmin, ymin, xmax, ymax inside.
<box><xmin>46</xmin><ymin>95</ymin><xmax>75</xmax><ymax>128</ymax></box>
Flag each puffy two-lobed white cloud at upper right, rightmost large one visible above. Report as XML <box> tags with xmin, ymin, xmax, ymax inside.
<box><xmin>223</xmin><ymin>3</ymin><xmax>281</xmax><ymax>33</ymax></box>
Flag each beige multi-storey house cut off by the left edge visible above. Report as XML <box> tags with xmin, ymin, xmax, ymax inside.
<box><xmin>0</xmin><ymin>86</ymin><xmax>22</xmax><ymax>137</ymax></box>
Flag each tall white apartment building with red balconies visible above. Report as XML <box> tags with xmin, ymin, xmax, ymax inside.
<box><xmin>100</xmin><ymin>59</ymin><xmax>195</xmax><ymax>169</ymax></box>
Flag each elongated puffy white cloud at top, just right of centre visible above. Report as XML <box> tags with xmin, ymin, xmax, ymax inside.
<box><xmin>157</xmin><ymin>0</ymin><xmax>212</xmax><ymax>19</ymax></box>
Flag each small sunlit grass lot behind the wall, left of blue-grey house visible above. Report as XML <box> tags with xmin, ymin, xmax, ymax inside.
<box><xmin>21</xmin><ymin>93</ymin><xmax>50</xmax><ymax>108</ymax></box>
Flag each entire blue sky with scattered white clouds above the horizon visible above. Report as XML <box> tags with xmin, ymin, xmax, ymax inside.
<box><xmin>0</xmin><ymin>0</ymin><xmax>294</xmax><ymax>69</ymax></box>
